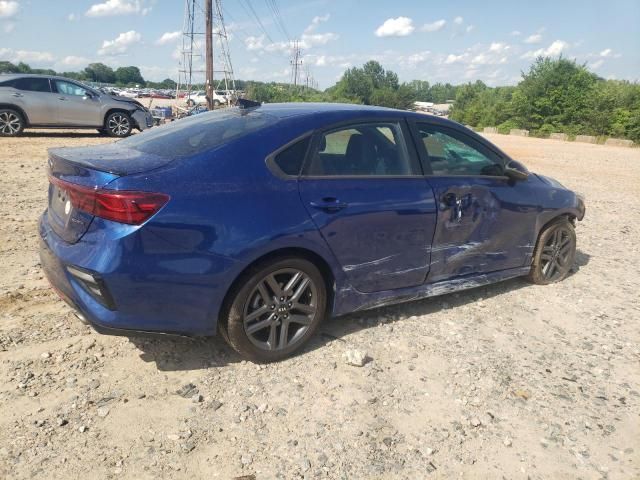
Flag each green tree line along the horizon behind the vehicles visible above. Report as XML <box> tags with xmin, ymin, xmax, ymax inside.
<box><xmin>0</xmin><ymin>57</ymin><xmax>640</xmax><ymax>143</ymax></box>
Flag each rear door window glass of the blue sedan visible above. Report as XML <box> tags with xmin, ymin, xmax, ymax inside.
<box><xmin>307</xmin><ymin>123</ymin><xmax>420</xmax><ymax>176</ymax></box>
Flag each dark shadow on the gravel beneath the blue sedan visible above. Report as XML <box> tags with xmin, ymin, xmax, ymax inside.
<box><xmin>129</xmin><ymin>250</ymin><xmax>590</xmax><ymax>371</ymax></box>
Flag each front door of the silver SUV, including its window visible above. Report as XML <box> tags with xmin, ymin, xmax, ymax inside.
<box><xmin>53</xmin><ymin>80</ymin><xmax>104</xmax><ymax>127</ymax></box>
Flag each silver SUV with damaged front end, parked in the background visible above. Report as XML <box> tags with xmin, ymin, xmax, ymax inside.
<box><xmin>0</xmin><ymin>74</ymin><xmax>153</xmax><ymax>137</ymax></box>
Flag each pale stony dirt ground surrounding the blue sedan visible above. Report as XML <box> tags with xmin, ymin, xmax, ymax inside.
<box><xmin>0</xmin><ymin>128</ymin><xmax>640</xmax><ymax>480</ymax></box>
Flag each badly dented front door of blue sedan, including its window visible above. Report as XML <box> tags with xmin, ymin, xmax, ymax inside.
<box><xmin>414</xmin><ymin>122</ymin><xmax>538</xmax><ymax>283</ymax></box>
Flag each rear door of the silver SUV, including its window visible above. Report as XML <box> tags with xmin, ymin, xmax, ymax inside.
<box><xmin>9</xmin><ymin>77</ymin><xmax>55</xmax><ymax>125</ymax></box>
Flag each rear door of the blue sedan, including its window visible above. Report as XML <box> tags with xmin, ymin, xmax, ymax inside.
<box><xmin>298</xmin><ymin>119</ymin><xmax>436</xmax><ymax>292</ymax></box>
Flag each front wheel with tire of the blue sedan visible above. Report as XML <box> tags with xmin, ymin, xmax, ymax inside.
<box><xmin>527</xmin><ymin>217</ymin><xmax>576</xmax><ymax>285</ymax></box>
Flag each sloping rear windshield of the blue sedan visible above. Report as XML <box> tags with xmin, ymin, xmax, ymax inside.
<box><xmin>118</xmin><ymin>108</ymin><xmax>278</xmax><ymax>158</ymax></box>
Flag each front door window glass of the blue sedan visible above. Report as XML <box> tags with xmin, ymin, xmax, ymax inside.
<box><xmin>418</xmin><ymin>124</ymin><xmax>504</xmax><ymax>176</ymax></box>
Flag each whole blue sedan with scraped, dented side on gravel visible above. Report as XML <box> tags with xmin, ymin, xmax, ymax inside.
<box><xmin>39</xmin><ymin>103</ymin><xmax>585</xmax><ymax>362</ymax></box>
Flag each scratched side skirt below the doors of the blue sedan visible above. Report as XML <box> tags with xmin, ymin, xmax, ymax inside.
<box><xmin>333</xmin><ymin>265</ymin><xmax>531</xmax><ymax>316</ymax></box>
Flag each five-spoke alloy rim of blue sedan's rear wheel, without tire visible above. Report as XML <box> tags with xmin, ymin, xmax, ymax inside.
<box><xmin>243</xmin><ymin>268</ymin><xmax>318</xmax><ymax>351</ymax></box>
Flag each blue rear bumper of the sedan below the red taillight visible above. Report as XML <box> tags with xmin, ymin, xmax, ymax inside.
<box><xmin>39</xmin><ymin>212</ymin><xmax>230</xmax><ymax>336</ymax></box>
